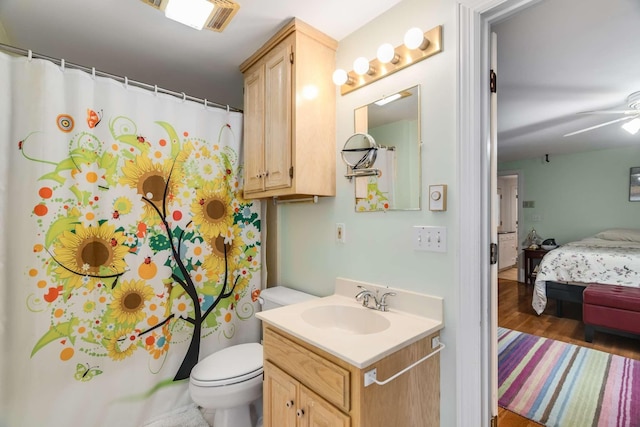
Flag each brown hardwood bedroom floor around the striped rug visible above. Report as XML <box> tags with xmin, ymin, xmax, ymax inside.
<box><xmin>498</xmin><ymin>272</ymin><xmax>640</xmax><ymax>427</ymax></box>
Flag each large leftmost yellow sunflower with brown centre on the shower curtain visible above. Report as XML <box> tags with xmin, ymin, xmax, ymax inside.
<box><xmin>54</xmin><ymin>222</ymin><xmax>129</xmax><ymax>289</ymax></box>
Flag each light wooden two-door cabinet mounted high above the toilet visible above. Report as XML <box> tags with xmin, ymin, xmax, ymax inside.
<box><xmin>240</xmin><ymin>18</ymin><xmax>337</xmax><ymax>199</ymax></box>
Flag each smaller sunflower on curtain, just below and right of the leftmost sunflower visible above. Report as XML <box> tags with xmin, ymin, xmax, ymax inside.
<box><xmin>109</xmin><ymin>280</ymin><xmax>153</xmax><ymax>325</ymax></box>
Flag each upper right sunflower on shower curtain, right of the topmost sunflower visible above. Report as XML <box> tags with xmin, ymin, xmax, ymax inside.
<box><xmin>191</xmin><ymin>184</ymin><xmax>233</xmax><ymax>240</ymax></box>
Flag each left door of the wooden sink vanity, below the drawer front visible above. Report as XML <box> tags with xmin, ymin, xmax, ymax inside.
<box><xmin>263</xmin><ymin>361</ymin><xmax>300</xmax><ymax>427</ymax></box>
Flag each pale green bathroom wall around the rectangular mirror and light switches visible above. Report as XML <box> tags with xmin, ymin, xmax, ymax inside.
<box><xmin>278</xmin><ymin>0</ymin><xmax>458</xmax><ymax>426</ymax></box>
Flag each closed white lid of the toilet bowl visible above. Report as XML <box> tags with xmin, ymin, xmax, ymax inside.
<box><xmin>191</xmin><ymin>343</ymin><xmax>262</xmax><ymax>386</ymax></box>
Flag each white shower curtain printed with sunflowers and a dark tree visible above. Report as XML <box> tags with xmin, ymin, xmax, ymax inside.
<box><xmin>0</xmin><ymin>53</ymin><xmax>262</xmax><ymax>427</ymax></box>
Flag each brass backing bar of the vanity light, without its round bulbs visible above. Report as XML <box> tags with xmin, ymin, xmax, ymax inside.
<box><xmin>340</xmin><ymin>25</ymin><xmax>442</xmax><ymax>95</ymax></box>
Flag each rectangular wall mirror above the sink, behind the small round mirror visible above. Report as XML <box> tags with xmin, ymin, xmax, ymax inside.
<box><xmin>350</xmin><ymin>86</ymin><xmax>421</xmax><ymax>212</ymax></box>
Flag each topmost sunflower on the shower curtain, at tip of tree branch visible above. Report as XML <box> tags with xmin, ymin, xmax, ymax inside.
<box><xmin>120</xmin><ymin>156</ymin><xmax>181</xmax><ymax>225</ymax></box>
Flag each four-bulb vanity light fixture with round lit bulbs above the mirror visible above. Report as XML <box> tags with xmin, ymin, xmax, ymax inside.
<box><xmin>333</xmin><ymin>25</ymin><xmax>442</xmax><ymax>95</ymax></box>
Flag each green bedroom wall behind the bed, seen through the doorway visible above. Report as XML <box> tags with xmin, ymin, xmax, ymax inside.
<box><xmin>498</xmin><ymin>143</ymin><xmax>640</xmax><ymax>244</ymax></box>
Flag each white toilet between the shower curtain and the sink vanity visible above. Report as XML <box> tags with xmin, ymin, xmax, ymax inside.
<box><xmin>189</xmin><ymin>286</ymin><xmax>317</xmax><ymax>427</ymax></box>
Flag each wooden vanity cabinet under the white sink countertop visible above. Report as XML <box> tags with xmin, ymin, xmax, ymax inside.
<box><xmin>263</xmin><ymin>324</ymin><xmax>440</xmax><ymax>427</ymax></box>
